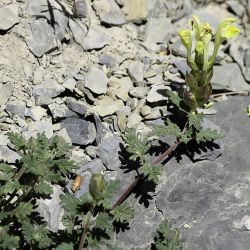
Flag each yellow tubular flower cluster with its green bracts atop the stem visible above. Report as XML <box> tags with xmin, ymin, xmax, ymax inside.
<box><xmin>179</xmin><ymin>16</ymin><xmax>239</xmax><ymax>110</ymax></box>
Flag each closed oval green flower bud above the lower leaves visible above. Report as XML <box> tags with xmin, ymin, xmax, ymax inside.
<box><xmin>89</xmin><ymin>174</ymin><xmax>105</xmax><ymax>200</ymax></box>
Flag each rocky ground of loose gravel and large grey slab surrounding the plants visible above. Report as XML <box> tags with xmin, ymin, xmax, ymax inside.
<box><xmin>0</xmin><ymin>0</ymin><xmax>250</xmax><ymax>250</ymax></box>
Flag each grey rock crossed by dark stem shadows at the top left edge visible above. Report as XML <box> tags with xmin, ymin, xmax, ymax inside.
<box><xmin>27</xmin><ymin>0</ymin><xmax>68</xmax><ymax>40</ymax></box>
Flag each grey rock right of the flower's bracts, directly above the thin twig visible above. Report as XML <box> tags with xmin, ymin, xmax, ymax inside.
<box><xmin>211</xmin><ymin>63</ymin><xmax>250</xmax><ymax>91</ymax></box>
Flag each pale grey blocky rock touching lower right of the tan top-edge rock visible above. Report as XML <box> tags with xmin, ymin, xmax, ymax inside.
<box><xmin>144</xmin><ymin>16</ymin><xmax>173</xmax><ymax>43</ymax></box>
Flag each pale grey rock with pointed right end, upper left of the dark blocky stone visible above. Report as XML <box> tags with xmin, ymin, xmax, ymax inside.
<box><xmin>33</xmin><ymin>79</ymin><xmax>65</xmax><ymax>99</ymax></box>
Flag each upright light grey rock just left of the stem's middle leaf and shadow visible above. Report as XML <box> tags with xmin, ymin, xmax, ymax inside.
<box><xmin>97</xmin><ymin>134</ymin><xmax>123</xmax><ymax>170</ymax></box>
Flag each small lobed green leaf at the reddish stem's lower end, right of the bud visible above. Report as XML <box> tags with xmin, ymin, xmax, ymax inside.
<box><xmin>110</xmin><ymin>203</ymin><xmax>134</xmax><ymax>223</ymax></box>
